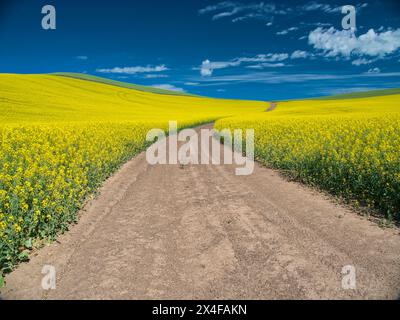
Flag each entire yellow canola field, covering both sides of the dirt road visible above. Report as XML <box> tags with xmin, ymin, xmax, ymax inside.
<box><xmin>0</xmin><ymin>74</ymin><xmax>400</xmax><ymax>280</ymax></box>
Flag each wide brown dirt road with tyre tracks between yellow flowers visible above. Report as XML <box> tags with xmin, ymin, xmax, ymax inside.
<box><xmin>2</xmin><ymin>124</ymin><xmax>400</xmax><ymax>299</ymax></box>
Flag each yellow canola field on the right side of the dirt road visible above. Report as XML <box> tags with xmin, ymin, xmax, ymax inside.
<box><xmin>216</xmin><ymin>94</ymin><xmax>400</xmax><ymax>221</ymax></box>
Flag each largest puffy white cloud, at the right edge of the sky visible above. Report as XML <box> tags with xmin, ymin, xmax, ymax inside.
<box><xmin>308</xmin><ymin>27</ymin><xmax>400</xmax><ymax>58</ymax></box>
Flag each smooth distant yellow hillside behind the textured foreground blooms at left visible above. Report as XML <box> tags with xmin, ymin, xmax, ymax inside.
<box><xmin>0</xmin><ymin>74</ymin><xmax>267</xmax><ymax>124</ymax></box>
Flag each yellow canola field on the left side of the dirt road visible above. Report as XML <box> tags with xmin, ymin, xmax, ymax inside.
<box><xmin>0</xmin><ymin>74</ymin><xmax>267</xmax><ymax>280</ymax></box>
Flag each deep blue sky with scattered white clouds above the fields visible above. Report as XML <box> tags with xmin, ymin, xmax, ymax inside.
<box><xmin>0</xmin><ymin>0</ymin><xmax>400</xmax><ymax>100</ymax></box>
